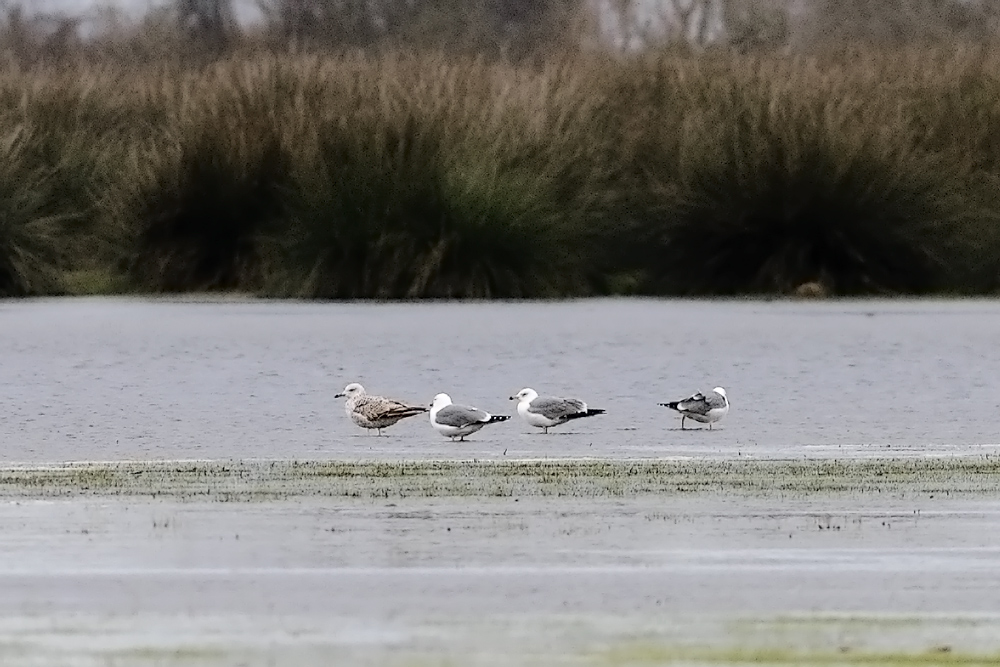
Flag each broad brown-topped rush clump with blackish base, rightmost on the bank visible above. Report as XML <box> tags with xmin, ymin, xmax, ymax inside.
<box><xmin>616</xmin><ymin>56</ymin><xmax>1000</xmax><ymax>295</ymax></box>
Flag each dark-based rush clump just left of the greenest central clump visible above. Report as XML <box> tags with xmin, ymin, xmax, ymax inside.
<box><xmin>116</xmin><ymin>97</ymin><xmax>289</xmax><ymax>292</ymax></box>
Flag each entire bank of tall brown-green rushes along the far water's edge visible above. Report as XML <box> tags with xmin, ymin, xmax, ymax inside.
<box><xmin>0</xmin><ymin>47</ymin><xmax>1000</xmax><ymax>299</ymax></box>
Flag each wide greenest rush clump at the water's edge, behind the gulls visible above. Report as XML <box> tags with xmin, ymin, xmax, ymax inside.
<box><xmin>269</xmin><ymin>116</ymin><xmax>578</xmax><ymax>298</ymax></box>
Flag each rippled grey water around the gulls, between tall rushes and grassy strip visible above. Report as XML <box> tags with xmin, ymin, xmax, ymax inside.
<box><xmin>0</xmin><ymin>299</ymin><xmax>1000</xmax><ymax>461</ymax></box>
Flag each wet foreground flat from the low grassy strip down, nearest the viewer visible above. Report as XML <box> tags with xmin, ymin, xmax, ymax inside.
<box><xmin>0</xmin><ymin>456</ymin><xmax>1000</xmax><ymax>666</ymax></box>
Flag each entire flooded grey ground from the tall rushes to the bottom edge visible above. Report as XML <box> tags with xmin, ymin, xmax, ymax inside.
<box><xmin>0</xmin><ymin>299</ymin><xmax>1000</xmax><ymax>667</ymax></box>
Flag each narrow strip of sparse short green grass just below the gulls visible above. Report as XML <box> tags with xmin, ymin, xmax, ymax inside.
<box><xmin>0</xmin><ymin>455</ymin><xmax>1000</xmax><ymax>502</ymax></box>
